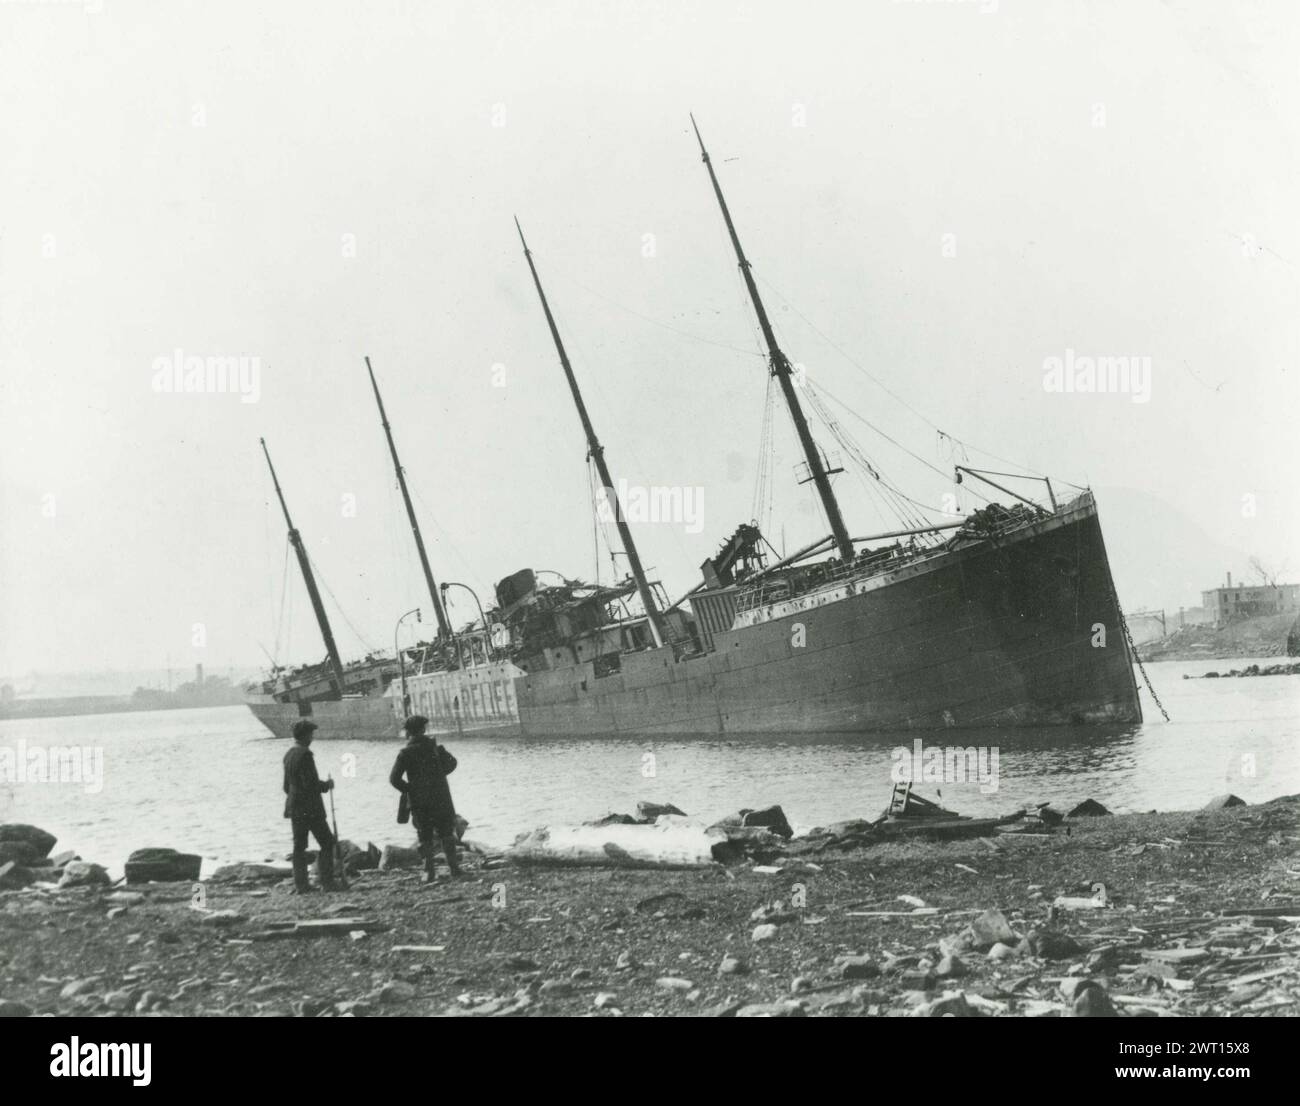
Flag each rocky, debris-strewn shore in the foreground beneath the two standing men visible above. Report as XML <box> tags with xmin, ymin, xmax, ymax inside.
<box><xmin>0</xmin><ymin>797</ymin><xmax>1300</xmax><ymax>1016</ymax></box>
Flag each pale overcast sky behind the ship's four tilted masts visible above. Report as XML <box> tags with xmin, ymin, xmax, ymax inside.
<box><xmin>0</xmin><ymin>0</ymin><xmax>1300</xmax><ymax>673</ymax></box>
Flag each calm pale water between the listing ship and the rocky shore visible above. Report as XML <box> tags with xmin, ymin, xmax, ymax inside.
<box><xmin>0</xmin><ymin>660</ymin><xmax>1300</xmax><ymax>871</ymax></box>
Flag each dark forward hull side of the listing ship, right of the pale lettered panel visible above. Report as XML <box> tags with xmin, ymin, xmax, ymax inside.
<box><xmin>412</xmin><ymin>495</ymin><xmax>1141</xmax><ymax>737</ymax></box>
